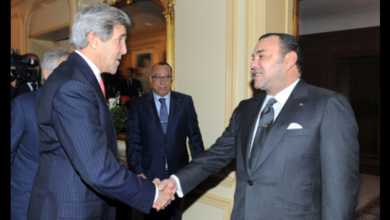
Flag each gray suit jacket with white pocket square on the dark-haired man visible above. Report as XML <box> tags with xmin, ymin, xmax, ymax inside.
<box><xmin>176</xmin><ymin>79</ymin><xmax>360</xmax><ymax>220</ymax></box>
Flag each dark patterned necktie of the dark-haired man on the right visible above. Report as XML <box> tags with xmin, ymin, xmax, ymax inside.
<box><xmin>249</xmin><ymin>98</ymin><xmax>276</xmax><ymax>169</ymax></box>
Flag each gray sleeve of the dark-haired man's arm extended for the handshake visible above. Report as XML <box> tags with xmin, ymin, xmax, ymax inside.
<box><xmin>175</xmin><ymin>101</ymin><xmax>239</xmax><ymax>194</ymax></box>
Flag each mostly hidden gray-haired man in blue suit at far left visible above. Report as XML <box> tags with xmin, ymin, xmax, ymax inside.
<box><xmin>11</xmin><ymin>49</ymin><xmax>70</xmax><ymax>220</ymax></box>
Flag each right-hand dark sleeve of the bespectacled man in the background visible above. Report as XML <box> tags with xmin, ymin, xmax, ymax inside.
<box><xmin>187</xmin><ymin>98</ymin><xmax>204</xmax><ymax>158</ymax></box>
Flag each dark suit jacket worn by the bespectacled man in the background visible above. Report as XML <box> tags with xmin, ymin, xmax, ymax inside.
<box><xmin>126</xmin><ymin>91</ymin><xmax>204</xmax><ymax>180</ymax></box>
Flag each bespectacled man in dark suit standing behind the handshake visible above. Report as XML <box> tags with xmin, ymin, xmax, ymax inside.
<box><xmin>126</xmin><ymin>62</ymin><xmax>204</xmax><ymax>220</ymax></box>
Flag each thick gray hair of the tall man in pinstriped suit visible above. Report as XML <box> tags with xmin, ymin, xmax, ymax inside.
<box><xmin>69</xmin><ymin>4</ymin><xmax>131</xmax><ymax>50</ymax></box>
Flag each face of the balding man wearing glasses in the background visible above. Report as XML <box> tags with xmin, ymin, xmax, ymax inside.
<box><xmin>150</xmin><ymin>65</ymin><xmax>172</xmax><ymax>97</ymax></box>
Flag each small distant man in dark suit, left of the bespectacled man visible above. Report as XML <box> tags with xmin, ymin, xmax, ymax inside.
<box><xmin>119</xmin><ymin>67</ymin><xmax>142</xmax><ymax>99</ymax></box>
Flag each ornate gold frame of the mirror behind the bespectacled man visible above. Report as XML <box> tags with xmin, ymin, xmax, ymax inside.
<box><xmin>107</xmin><ymin>0</ymin><xmax>176</xmax><ymax>90</ymax></box>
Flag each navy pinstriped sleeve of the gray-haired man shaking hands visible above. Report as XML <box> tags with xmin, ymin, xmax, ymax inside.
<box><xmin>52</xmin><ymin>81</ymin><xmax>156</xmax><ymax>213</ymax></box>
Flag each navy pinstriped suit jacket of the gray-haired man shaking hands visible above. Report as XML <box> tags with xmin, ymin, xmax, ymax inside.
<box><xmin>28</xmin><ymin>53</ymin><xmax>156</xmax><ymax>220</ymax></box>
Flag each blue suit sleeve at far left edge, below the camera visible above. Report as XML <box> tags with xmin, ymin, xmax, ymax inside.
<box><xmin>11</xmin><ymin>99</ymin><xmax>25</xmax><ymax>166</ymax></box>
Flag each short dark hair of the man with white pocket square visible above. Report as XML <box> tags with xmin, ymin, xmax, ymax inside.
<box><xmin>259</xmin><ymin>33</ymin><xmax>304</xmax><ymax>75</ymax></box>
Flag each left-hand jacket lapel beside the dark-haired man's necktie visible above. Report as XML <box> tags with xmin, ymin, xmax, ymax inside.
<box><xmin>241</xmin><ymin>93</ymin><xmax>266</xmax><ymax>174</ymax></box>
